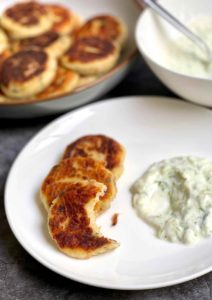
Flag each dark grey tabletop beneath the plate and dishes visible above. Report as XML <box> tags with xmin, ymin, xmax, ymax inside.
<box><xmin>0</xmin><ymin>59</ymin><xmax>212</xmax><ymax>300</ymax></box>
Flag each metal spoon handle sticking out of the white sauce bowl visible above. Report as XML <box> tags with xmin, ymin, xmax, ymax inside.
<box><xmin>142</xmin><ymin>0</ymin><xmax>212</xmax><ymax>61</ymax></box>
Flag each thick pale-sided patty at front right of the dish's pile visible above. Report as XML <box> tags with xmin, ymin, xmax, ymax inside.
<box><xmin>61</xmin><ymin>37</ymin><xmax>119</xmax><ymax>75</ymax></box>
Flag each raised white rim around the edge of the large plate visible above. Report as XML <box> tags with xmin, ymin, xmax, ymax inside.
<box><xmin>4</xmin><ymin>95</ymin><xmax>212</xmax><ymax>290</ymax></box>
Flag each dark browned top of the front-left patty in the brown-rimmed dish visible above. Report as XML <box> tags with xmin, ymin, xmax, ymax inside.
<box><xmin>1</xmin><ymin>50</ymin><xmax>48</xmax><ymax>86</ymax></box>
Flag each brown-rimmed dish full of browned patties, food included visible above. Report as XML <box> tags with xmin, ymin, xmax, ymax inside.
<box><xmin>0</xmin><ymin>0</ymin><xmax>140</xmax><ymax>118</ymax></box>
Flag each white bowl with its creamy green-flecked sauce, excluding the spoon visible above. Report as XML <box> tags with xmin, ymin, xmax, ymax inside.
<box><xmin>135</xmin><ymin>0</ymin><xmax>212</xmax><ymax>107</ymax></box>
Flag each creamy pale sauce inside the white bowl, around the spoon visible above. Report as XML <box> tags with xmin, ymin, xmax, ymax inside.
<box><xmin>163</xmin><ymin>17</ymin><xmax>212</xmax><ymax>78</ymax></box>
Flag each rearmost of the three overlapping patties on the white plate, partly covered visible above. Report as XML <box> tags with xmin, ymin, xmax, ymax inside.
<box><xmin>63</xmin><ymin>135</ymin><xmax>125</xmax><ymax>178</ymax></box>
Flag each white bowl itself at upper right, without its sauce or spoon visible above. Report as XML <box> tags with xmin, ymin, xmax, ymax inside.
<box><xmin>135</xmin><ymin>0</ymin><xmax>212</xmax><ymax>107</ymax></box>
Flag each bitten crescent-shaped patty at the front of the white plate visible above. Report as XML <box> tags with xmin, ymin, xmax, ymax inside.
<box><xmin>48</xmin><ymin>180</ymin><xmax>118</xmax><ymax>258</ymax></box>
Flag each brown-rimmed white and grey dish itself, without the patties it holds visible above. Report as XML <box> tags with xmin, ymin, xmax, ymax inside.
<box><xmin>0</xmin><ymin>0</ymin><xmax>140</xmax><ymax>118</ymax></box>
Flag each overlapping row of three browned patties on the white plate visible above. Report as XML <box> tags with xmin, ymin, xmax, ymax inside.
<box><xmin>40</xmin><ymin>135</ymin><xmax>125</xmax><ymax>258</ymax></box>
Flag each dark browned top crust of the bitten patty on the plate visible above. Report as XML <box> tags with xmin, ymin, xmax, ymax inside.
<box><xmin>49</xmin><ymin>183</ymin><xmax>110</xmax><ymax>252</ymax></box>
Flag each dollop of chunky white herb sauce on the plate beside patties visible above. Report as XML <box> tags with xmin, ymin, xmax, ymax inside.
<box><xmin>131</xmin><ymin>156</ymin><xmax>212</xmax><ymax>244</ymax></box>
